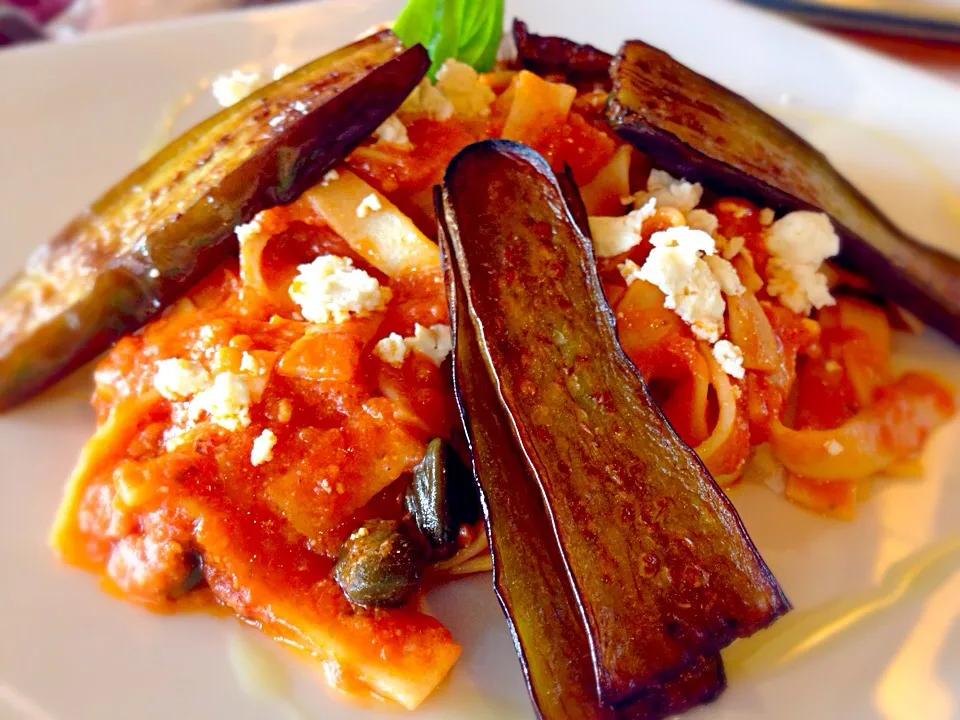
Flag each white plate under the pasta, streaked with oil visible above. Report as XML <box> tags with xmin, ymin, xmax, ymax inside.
<box><xmin>0</xmin><ymin>0</ymin><xmax>960</xmax><ymax>720</ymax></box>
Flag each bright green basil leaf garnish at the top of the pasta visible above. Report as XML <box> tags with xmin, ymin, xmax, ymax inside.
<box><xmin>393</xmin><ymin>0</ymin><xmax>503</xmax><ymax>77</ymax></box>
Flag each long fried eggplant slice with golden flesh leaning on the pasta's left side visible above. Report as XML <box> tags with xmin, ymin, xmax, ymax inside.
<box><xmin>0</xmin><ymin>31</ymin><xmax>430</xmax><ymax>409</ymax></box>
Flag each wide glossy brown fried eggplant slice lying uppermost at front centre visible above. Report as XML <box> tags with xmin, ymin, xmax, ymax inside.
<box><xmin>443</xmin><ymin>140</ymin><xmax>790</xmax><ymax>704</ymax></box>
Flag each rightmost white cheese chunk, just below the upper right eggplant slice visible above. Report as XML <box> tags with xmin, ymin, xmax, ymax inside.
<box><xmin>766</xmin><ymin>210</ymin><xmax>840</xmax><ymax>315</ymax></box>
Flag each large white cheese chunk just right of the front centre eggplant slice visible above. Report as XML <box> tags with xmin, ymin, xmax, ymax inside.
<box><xmin>621</xmin><ymin>227</ymin><xmax>726</xmax><ymax>343</ymax></box>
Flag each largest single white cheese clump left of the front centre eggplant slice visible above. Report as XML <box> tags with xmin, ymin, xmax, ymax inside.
<box><xmin>290</xmin><ymin>255</ymin><xmax>391</xmax><ymax>323</ymax></box>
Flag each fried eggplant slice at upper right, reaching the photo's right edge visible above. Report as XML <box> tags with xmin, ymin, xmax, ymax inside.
<box><xmin>607</xmin><ymin>40</ymin><xmax>960</xmax><ymax>343</ymax></box>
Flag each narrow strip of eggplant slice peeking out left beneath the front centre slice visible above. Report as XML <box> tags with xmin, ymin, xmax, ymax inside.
<box><xmin>438</xmin><ymin>217</ymin><xmax>615</xmax><ymax>720</ymax></box>
